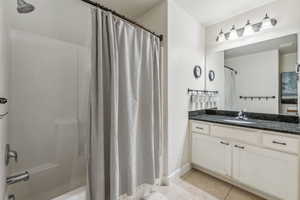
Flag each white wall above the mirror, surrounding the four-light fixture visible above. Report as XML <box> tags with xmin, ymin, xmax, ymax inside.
<box><xmin>206</xmin><ymin>0</ymin><xmax>300</xmax><ymax>51</ymax></box>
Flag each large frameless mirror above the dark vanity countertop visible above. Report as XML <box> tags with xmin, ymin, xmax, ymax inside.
<box><xmin>224</xmin><ymin>34</ymin><xmax>298</xmax><ymax>115</ymax></box>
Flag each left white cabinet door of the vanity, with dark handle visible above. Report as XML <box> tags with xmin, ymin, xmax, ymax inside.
<box><xmin>192</xmin><ymin>134</ymin><xmax>232</xmax><ymax>176</ymax></box>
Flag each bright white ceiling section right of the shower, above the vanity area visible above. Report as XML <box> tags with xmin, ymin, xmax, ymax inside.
<box><xmin>175</xmin><ymin>0</ymin><xmax>275</xmax><ymax>26</ymax></box>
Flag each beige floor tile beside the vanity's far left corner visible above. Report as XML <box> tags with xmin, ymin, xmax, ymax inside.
<box><xmin>183</xmin><ymin>171</ymin><xmax>232</xmax><ymax>200</ymax></box>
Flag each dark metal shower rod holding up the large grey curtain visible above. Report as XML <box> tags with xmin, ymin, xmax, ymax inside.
<box><xmin>81</xmin><ymin>0</ymin><xmax>163</xmax><ymax>41</ymax></box>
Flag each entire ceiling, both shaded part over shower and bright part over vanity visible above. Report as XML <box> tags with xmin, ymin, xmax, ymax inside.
<box><xmin>95</xmin><ymin>0</ymin><xmax>276</xmax><ymax>25</ymax></box>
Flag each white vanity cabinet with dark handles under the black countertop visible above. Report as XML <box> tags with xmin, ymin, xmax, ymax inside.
<box><xmin>191</xmin><ymin>121</ymin><xmax>300</xmax><ymax>200</ymax></box>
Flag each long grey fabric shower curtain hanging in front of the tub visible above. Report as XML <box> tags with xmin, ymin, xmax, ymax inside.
<box><xmin>88</xmin><ymin>8</ymin><xmax>162</xmax><ymax>200</ymax></box>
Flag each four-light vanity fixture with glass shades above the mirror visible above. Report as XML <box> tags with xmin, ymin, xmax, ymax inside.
<box><xmin>216</xmin><ymin>14</ymin><xmax>277</xmax><ymax>42</ymax></box>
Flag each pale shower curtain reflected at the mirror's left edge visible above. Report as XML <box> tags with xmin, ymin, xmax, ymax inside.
<box><xmin>224</xmin><ymin>68</ymin><xmax>237</xmax><ymax>110</ymax></box>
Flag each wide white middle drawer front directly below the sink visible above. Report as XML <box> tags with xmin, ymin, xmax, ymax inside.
<box><xmin>211</xmin><ymin>126</ymin><xmax>261</xmax><ymax>145</ymax></box>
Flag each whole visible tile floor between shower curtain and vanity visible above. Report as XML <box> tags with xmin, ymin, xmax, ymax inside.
<box><xmin>155</xmin><ymin>170</ymin><xmax>264</xmax><ymax>200</ymax></box>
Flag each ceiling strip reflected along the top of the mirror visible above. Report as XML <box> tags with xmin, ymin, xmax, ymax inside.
<box><xmin>225</xmin><ymin>34</ymin><xmax>298</xmax><ymax>59</ymax></box>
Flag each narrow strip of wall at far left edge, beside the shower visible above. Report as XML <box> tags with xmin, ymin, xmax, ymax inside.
<box><xmin>0</xmin><ymin>0</ymin><xmax>9</xmax><ymax>199</ymax></box>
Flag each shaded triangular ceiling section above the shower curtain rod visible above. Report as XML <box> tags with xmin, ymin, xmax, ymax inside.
<box><xmin>95</xmin><ymin>0</ymin><xmax>161</xmax><ymax>19</ymax></box>
